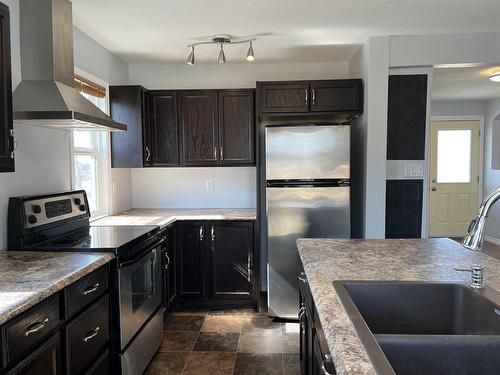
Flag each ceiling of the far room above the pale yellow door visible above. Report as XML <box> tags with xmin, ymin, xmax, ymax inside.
<box><xmin>431</xmin><ymin>65</ymin><xmax>500</xmax><ymax>100</ymax></box>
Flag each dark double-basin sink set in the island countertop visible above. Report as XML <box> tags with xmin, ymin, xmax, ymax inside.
<box><xmin>333</xmin><ymin>281</ymin><xmax>500</xmax><ymax>375</ymax></box>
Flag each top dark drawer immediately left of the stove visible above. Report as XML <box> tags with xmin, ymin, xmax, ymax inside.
<box><xmin>65</xmin><ymin>266</ymin><xmax>109</xmax><ymax>318</ymax></box>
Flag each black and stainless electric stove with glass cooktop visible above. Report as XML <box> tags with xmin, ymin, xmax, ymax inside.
<box><xmin>7</xmin><ymin>190</ymin><xmax>165</xmax><ymax>375</ymax></box>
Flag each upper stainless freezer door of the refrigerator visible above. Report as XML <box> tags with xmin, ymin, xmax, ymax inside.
<box><xmin>266</xmin><ymin>125</ymin><xmax>350</xmax><ymax>180</ymax></box>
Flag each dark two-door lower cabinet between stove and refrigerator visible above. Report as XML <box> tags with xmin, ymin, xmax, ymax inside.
<box><xmin>173</xmin><ymin>220</ymin><xmax>257</xmax><ymax>306</ymax></box>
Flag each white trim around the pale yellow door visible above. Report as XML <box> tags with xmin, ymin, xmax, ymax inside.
<box><xmin>423</xmin><ymin>115</ymin><xmax>484</xmax><ymax>238</ymax></box>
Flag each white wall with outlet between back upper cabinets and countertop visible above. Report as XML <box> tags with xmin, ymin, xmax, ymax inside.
<box><xmin>132</xmin><ymin>167</ymin><xmax>256</xmax><ymax>208</ymax></box>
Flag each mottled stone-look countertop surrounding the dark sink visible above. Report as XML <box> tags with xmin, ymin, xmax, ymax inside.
<box><xmin>297</xmin><ymin>239</ymin><xmax>500</xmax><ymax>375</ymax></box>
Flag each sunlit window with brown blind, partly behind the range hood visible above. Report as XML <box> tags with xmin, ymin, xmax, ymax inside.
<box><xmin>72</xmin><ymin>76</ymin><xmax>110</xmax><ymax>217</ymax></box>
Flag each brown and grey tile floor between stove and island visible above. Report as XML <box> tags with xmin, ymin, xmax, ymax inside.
<box><xmin>146</xmin><ymin>310</ymin><xmax>300</xmax><ymax>375</ymax></box>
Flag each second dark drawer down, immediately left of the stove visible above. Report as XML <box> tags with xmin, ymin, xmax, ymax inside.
<box><xmin>65</xmin><ymin>294</ymin><xmax>109</xmax><ymax>375</ymax></box>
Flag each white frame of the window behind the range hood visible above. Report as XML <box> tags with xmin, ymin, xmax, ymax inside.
<box><xmin>70</xmin><ymin>67</ymin><xmax>112</xmax><ymax>221</ymax></box>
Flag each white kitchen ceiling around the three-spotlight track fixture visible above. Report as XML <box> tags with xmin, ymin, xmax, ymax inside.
<box><xmin>72</xmin><ymin>0</ymin><xmax>500</xmax><ymax>63</ymax></box>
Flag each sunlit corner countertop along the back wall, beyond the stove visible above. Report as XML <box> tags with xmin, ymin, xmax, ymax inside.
<box><xmin>92</xmin><ymin>208</ymin><xmax>257</xmax><ymax>228</ymax></box>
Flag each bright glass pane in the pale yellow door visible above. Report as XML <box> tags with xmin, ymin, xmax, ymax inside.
<box><xmin>437</xmin><ymin>129</ymin><xmax>472</xmax><ymax>184</ymax></box>
